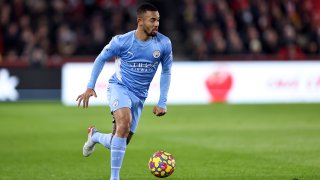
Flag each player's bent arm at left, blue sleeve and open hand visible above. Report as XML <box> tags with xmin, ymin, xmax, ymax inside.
<box><xmin>77</xmin><ymin>39</ymin><xmax>117</xmax><ymax>108</ymax></box>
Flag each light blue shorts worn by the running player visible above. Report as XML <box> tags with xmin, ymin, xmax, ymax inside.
<box><xmin>107</xmin><ymin>83</ymin><xmax>144</xmax><ymax>133</ymax></box>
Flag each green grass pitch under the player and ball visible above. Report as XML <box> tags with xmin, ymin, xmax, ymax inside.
<box><xmin>0</xmin><ymin>102</ymin><xmax>320</xmax><ymax>180</ymax></box>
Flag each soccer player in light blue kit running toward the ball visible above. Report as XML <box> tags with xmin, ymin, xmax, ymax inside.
<box><xmin>77</xmin><ymin>4</ymin><xmax>173</xmax><ymax>180</ymax></box>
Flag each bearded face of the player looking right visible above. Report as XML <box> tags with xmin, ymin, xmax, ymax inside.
<box><xmin>141</xmin><ymin>11</ymin><xmax>160</xmax><ymax>36</ymax></box>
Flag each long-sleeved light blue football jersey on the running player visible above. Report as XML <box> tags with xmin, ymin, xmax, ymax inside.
<box><xmin>87</xmin><ymin>30</ymin><xmax>173</xmax><ymax>108</ymax></box>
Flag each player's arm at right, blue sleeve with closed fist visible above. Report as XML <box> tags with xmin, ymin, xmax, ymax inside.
<box><xmin>153</xmin><ymin>41</ymin><xmax>173</xmax><ymax>116</ymax></box>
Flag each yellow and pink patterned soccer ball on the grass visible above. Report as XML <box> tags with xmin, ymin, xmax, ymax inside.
<box><xmin>149</xmin><ymin>151</ymin><xmax>176</xmax><ymax>178</ymax></box>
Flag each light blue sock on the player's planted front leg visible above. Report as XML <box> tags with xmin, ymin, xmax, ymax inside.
<box><xmin>110</xmin><ymin>137</ymin><xmax>127</xmax><ymax>180</ymax></box>
